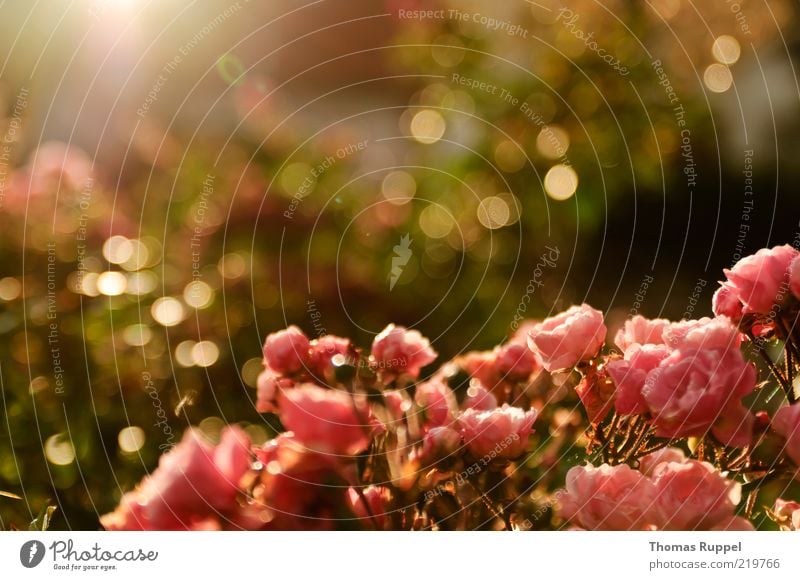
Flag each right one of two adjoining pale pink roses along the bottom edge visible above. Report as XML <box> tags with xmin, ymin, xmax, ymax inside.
<box><xmin>652</xmin><ymin>459</ymin><xmax>752</xmax><ymax>531</ymax></box>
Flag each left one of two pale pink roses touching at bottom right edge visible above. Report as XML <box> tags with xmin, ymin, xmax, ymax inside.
<box><xmin>559</xmin><ymin>464</ymin><xmax>658</xmax><ymax>530</ymax></box>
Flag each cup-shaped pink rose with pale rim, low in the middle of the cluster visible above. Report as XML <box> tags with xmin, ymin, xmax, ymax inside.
<box><xmin>458</xmin><ymin>405</ymin><xmax>536</xmax><ymax>459</ymax></box>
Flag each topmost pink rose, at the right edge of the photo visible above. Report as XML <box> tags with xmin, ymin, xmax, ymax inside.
<box><xmin>724</xmin><ymin>244</ymin><xmax>798</xmax><ymax>314</ymax></box>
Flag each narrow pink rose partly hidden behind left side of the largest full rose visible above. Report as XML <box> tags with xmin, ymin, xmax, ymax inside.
<box><xmin>605</xmin><ymin>343</ymin><xmax>669</xmax><ymax>415</ymax></box>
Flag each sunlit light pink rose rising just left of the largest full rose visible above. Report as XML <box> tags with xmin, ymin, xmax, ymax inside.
<box><xmin>528</xmin><ymin>304</ymin><xmax>606</xmax><ymax>372</ymax></box>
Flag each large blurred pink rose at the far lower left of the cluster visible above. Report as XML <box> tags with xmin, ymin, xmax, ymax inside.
<box><xmin>100</xmin><ymin>427</ymin><xmax>251</xmax><ymax>530</ymax></box>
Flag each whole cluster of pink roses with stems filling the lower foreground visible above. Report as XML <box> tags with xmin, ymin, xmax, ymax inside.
<box><xmin>102</xmin><ymin>246</ymin><xmax>800</xmax><ymax>530</ymax></box>
